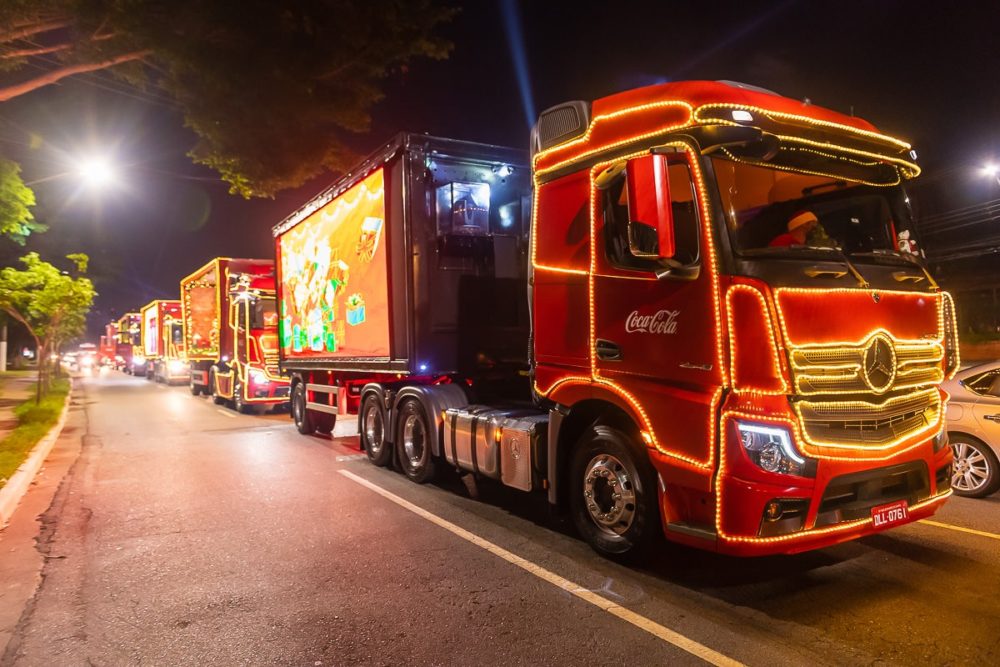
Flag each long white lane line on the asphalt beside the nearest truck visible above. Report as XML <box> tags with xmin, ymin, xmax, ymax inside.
<box><xmin>337</xmin><ymin>470</ymin><xmax>743</xmax><ymax>667</ymax></box>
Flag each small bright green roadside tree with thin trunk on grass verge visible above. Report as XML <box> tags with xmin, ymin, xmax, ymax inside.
<box><xmin>0</xmin><ymin>252</ymin><xmax>96</xmax><ymax>402</ymax></box>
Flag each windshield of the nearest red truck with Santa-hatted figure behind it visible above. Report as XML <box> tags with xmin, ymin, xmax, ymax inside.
<box><xmin>712</xmin><ymin>158</ymin><xmax>922</xmax><ymax>256</ymax></box>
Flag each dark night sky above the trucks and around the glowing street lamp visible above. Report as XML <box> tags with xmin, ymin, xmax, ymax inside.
<box><xmin>0</xmin><ymin>0</ymin><xmax>1000</xmax><ymax>337</ymax></box>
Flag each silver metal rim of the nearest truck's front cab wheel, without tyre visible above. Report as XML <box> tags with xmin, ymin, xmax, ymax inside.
<box><xmin>583</xmin><ymin>454</ymin><xmax>636</xmax><ymax>536</ymax></box>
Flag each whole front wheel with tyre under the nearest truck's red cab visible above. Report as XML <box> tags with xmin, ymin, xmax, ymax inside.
<box><xmin>570</xmin><ymin>424</ymin><xmax>660</xmax><ymax>560</ymax></box>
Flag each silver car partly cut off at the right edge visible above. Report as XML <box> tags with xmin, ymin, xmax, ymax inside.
<box><xmin>942</xmin><ymin>361</ymin><xmax>1000</xmax><ymax>498</ymax></box>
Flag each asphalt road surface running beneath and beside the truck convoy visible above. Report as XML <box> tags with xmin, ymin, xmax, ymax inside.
<box><xmin>0</xmin><ymin>373</ymin><xmax>1000</xmax><ymax>667</ymax></box>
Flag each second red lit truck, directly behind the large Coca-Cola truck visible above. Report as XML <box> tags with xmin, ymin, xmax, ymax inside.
<box><xmin>181</xmin><ymin>257</ymin><xmax>288</xmax><ymax>412</ymax></box>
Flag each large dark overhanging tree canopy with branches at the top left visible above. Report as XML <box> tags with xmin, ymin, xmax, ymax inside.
<box><xmin>0</xmin><ymin>0</ymin><xmax>454</xmax><ymax>197</ymax></box>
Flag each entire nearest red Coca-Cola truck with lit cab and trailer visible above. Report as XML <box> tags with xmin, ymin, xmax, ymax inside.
<box><xmin>274</xmin><ymin>81</ymin><xmax>959</xmax><ymax>557</ymax></box>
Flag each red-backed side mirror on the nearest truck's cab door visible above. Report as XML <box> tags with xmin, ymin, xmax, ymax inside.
<box><xmin>625</xmin><ymin>153</ymin><xmax>675</xmax><ymax>259</ymax></box>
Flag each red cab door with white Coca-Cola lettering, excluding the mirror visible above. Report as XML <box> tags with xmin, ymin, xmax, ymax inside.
<box><xmin>592</xmin><ymin>151</ymin><xmax>723</xmax><ymax>470</ymax></box>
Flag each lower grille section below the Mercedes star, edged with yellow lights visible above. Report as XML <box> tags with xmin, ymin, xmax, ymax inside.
<box><xmin>794</xmin><ymin>388</ymin><xmax>941</xmax><ymax>449</ymax></box>
